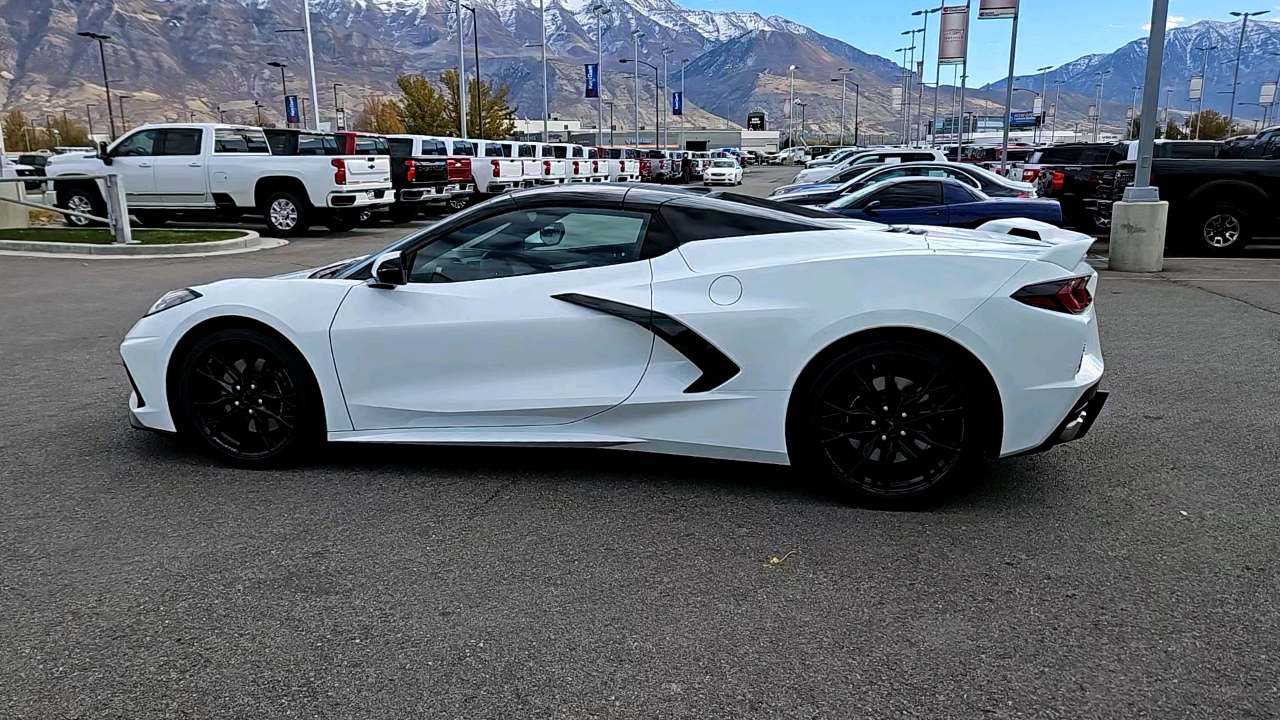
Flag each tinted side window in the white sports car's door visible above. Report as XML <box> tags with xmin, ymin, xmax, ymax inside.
<box><xmin>410</xmin><ymin>208</ymin><xmax>649</xmax><ymax>283</ymax></box>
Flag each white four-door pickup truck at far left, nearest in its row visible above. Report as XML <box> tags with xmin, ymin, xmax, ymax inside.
<box><xmin>45</xmin><ymin>123</ymin><xmax>396</xmax><ymax>236</ymax></box>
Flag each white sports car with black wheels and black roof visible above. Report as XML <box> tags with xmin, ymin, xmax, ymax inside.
<box><xmin>120</xmin><ymin>184</ymin><xmax>1106</xmax><ymax>506</ymax></box>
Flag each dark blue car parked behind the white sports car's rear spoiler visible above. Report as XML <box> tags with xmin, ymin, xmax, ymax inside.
<box><xmin>824</xmin><ymin>177</ymin><xmax>1062</xmax><ymax>228</ymax></box>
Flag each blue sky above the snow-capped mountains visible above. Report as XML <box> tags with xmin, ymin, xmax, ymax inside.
<box><xmin>677</xmin><ymin>0</ymin><xmax>1280</xmax><ymax>85</ymax></box>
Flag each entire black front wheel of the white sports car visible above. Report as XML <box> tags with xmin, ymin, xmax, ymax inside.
<box><xmin>174</xmin><ymin>329</ymin><xmax>324</xmax><ymax>468</ymax></box>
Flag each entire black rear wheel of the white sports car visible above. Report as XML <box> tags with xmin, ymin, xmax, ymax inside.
<box><xmin>787</xmin><ymin>341</ymin><xmax>986</xmax><ymax>510</ymax></box>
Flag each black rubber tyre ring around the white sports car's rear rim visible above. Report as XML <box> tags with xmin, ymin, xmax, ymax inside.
<box><xmin>787</xmin><ymin>341</ymin><xmax>987</xmax><ymax>510</ymax></box>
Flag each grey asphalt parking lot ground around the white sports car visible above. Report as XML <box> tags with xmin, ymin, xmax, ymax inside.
<box><xmin>0</xmin><ymin>168</ymin><xmax>1280</xmax><ymax>720</ymax></box>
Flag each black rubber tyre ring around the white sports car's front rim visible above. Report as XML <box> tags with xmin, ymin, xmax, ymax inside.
<box><xmin>170</xmin><ymin>328</ymin><xmax>323</xmax><ymax>468</ymax></box>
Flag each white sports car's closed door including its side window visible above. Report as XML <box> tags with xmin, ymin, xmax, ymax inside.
<box><xmin>330</xmin><ymin>193</ymin><xmax>653</xmax><ymax>429</ymax></box>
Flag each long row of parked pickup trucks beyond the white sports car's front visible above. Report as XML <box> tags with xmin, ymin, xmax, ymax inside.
<box><xmin>45</xmin><ymin>123</ymin><xmax>741</xmax><ymax>236</ymax></box>
